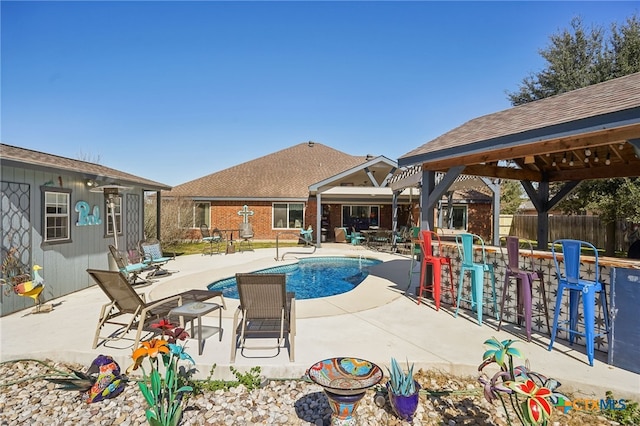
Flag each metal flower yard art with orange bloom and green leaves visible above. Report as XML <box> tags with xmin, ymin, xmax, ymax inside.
<box><xmin>128</xmin><ymin>320</ymin><xmax>194</xmax><ymax>426</ymax></box>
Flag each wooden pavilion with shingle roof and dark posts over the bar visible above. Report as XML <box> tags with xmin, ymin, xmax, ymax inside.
<box><xmin>398</xmin><ymin>73</ymin><xmax>640</xmax><ymax>249</ymax></box>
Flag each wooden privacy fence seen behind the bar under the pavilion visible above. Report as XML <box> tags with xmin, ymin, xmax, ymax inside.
<box><xmin>500</xmin><ymin>215</ymin><xmax>629</xmax><ymax>251</ymax></box>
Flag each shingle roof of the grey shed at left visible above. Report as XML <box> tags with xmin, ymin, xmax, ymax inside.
<box><xmin>0</xmin><ymin>144</ymin><xmax>171</xmax><ymax>190</ymax></box>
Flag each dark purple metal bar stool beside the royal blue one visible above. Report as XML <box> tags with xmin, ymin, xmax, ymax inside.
<box><xmin>498</xmin><ymin>236</ymin><xmax>551</xmax><ymax>342</ymax></box>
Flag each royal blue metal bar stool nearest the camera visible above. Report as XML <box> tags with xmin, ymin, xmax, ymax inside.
<box><xmin>548</xmin><ymin>240</ymin><xmax>609</xmax><ymax>366</ymax></box>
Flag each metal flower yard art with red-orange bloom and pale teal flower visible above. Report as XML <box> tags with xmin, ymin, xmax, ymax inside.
<box><xmin>478</xmin><ymin>337</ymin><xmax>569</xmax><ymax>425</ymax></box>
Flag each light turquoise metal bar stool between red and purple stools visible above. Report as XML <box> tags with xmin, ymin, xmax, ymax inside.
<box><xmin>454</xmin><ymin>234</ymin><xmax>499</xmax><ymax>325</ymax></box>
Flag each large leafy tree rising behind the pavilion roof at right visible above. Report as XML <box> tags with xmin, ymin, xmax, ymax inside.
<box><xmin>507</xmin><ymin>14</ymin><xmax>640</xmax><ymax>255</ymax></box>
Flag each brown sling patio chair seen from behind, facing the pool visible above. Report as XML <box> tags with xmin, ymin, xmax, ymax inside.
<box><xmin>231</xmin><ymin>274</ymin><xmax>296</xmax><ymax>362</ymax></box>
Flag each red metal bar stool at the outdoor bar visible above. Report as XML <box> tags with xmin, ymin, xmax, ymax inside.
<box><xmin>417</xmin><ymin>231</ymin><xmax>456</xmax><ymax>311</ymax></box>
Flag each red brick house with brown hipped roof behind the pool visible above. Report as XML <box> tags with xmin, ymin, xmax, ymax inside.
<box><xmin>162</xmin><ymin>141</ymin><xmax>418</xmax><ymax>242</ymax></box>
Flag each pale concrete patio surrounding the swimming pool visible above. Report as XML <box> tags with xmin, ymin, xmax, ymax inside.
<box><xmin>0</xmin><ymin>244</ymin><xmax>640</xmax><ymax>400</ymax></box>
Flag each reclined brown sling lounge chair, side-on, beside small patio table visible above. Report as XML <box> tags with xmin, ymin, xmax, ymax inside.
<box><xmin>87</xmin><ymin>269</ymin><xmax>226</xmax><ymax>349</ymax></box>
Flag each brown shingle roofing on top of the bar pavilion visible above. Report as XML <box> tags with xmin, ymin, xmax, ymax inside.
<box><xmin>400</xmin><ymin>73</ymin><xmax>640</xmax><ymax>160</ymax></box>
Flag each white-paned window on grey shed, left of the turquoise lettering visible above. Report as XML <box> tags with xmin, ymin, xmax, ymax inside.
<box><xmin>42</xmin><ymin>187</ymin><xmax>71</xmax><ymax>243</ymax></box>
